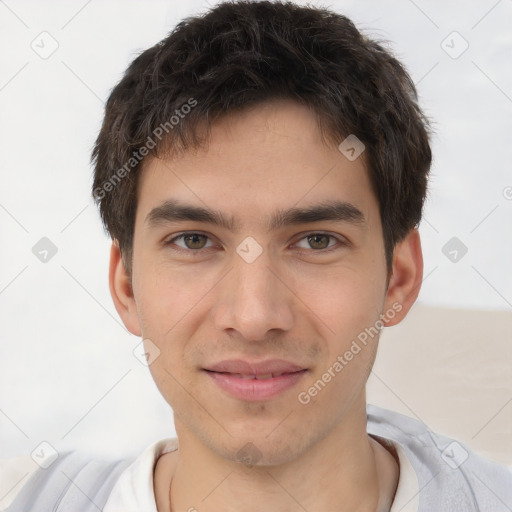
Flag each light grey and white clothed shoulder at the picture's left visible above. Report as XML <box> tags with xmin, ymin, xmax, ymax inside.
<box><xmin>0</xmin><ymin>438</ymin><xmax>178</xmax><ymax>512</ymax></box>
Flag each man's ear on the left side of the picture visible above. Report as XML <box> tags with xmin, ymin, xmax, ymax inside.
<box><xmin>108</xmin><ymin>240</ymin><xmax>141</xmax><ymax>336</ymax></box>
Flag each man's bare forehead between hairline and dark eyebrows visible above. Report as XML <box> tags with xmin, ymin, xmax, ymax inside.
<box><xmin>137</xmin><ymin>100</ymin><xmax>376</xmax><ymax>230</ymax></box>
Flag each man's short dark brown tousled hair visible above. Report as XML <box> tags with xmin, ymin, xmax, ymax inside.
<box><xmin>92</xmin><ymin>1</ymin><xmax>431</xmax><ymax>272</ymax></box>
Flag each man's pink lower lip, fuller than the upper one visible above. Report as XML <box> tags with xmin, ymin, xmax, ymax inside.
<box><xmin>206</xmin><ymin>370</ymin><xmax>307</xmax><ymax>401</ymax></box>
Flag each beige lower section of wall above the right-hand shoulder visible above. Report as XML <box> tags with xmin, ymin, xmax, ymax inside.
<box><xmin>367</xmin><ymin>304</ymin><xmax>512</xmax><ymax>466</ymax></box>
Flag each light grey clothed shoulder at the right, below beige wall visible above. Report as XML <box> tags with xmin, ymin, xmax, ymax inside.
<box><xmin>367</xmin><ymin>405</ymin><xmax>512</xmax><ymax>512</ymax></box>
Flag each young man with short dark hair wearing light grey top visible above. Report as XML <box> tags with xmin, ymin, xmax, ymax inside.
<box><xmin>4</xmin><ymin>2</ymin><xmax>512</xmax><ymax>512</ymax></box>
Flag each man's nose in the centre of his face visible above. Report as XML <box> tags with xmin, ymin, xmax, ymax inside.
<box><xmin>214</xmin><ymin>247</ymin><xmax>294</xmax><ymax>342</ymax></box>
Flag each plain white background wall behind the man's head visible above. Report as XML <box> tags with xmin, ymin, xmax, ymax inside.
<box><xmin>0</xmin><ymin>0</ymin><xmax>512</xmax><ymax>457</ymax></box>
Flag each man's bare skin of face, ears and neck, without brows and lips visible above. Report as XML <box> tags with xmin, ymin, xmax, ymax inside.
<box><xmin>110</xmin><ymin>100</ymin><xmax>423</xmax><ymax>512</ymax></box>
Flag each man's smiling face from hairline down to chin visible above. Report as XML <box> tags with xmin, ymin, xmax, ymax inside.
<box><xmin>112</xmin><ymin>101</ymin><xmax>420</xmax><ymax>464</ymax></box>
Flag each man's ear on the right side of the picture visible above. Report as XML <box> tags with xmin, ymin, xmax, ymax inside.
<box><xmin>382</xmin><ymin>229</ymin><xmax>423</xmax><ymax>327</ymax></box>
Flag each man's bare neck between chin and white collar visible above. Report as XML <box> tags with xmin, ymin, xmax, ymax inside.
<box><xmin>155</xmin><ymin>405</ymin><xmax>398</xmax><ymax>512</ymax></box>
